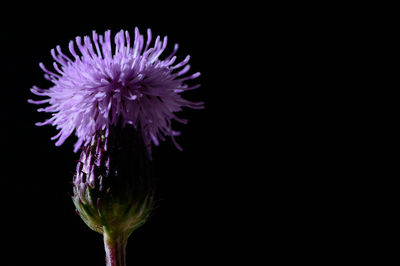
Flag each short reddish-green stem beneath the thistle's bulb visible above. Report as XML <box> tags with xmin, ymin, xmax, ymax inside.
<box><xmin>104</xmin><ymin>233</ymin><xmax>127</xmax><ymax>266</ymax></box>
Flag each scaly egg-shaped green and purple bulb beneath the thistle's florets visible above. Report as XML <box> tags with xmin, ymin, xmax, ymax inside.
<box><xmin>72</xmin><ymin>126</ymin><xmax>154</xmax><ymax>240</ymax></box>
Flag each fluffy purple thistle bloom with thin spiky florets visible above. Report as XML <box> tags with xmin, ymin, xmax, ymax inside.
<box><xmin>28</xmin><ymin>28</ymin><xmax>203</xmax><ymax>152</ymax></box>
